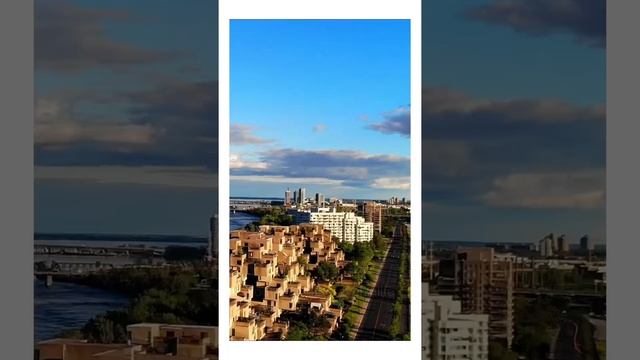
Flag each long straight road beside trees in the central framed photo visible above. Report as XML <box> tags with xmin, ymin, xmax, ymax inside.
<box><xmin>356</xmin><ymin>224</ymin><xmax>403</xmax><ymax>340</ymax></box>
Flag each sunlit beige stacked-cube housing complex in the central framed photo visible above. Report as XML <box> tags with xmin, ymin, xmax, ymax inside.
<box><xmin>229</xmin><ymin>224</ymin><xmax>345</xmax><ymax>340</ymax></box>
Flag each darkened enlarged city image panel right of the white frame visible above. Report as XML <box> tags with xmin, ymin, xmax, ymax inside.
<box><xmin>422</xmin><ymin>0</ymin><xmax>606</xmax><ymax>359</ymax></box>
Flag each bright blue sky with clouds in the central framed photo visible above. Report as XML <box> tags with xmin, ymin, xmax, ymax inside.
<box><xmin>230</xmin><ymin>20</ymin><xmax>410</xmax><ymax>198</ymax></box>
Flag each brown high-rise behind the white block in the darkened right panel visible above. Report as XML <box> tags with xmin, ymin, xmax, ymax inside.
<box><xmin>437</xmin><ymin>248</ymin><xmax>514</xmax><ymax>348</ymax></box>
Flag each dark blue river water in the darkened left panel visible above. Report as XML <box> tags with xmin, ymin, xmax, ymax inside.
<box><xmin>33</xmin><ymin>280</ymin><xmax>128</xmax><ymax>341</ymax></box>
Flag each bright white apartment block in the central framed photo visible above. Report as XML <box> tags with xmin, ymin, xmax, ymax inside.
<box><xmin>294</xmin><ymin>208</ymin><xmax>373</xmax><ymax>243</ymax></box>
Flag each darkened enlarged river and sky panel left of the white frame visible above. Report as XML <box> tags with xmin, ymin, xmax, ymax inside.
<box><xmin>33</xmin><ymin>0</ymin><xmax>218</xmax><ymax>359</ymax></box>
